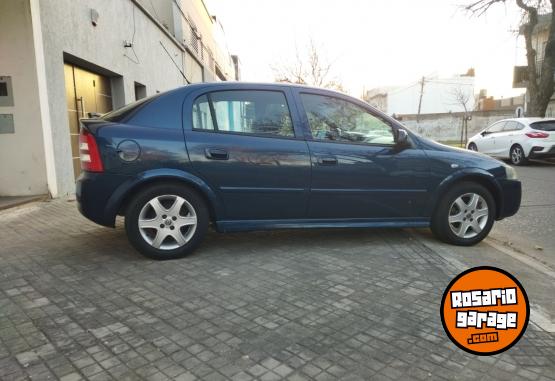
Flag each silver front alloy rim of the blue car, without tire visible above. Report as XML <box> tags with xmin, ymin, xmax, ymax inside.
<box><xmin>449</xmin><ymin>193</ymin><xmax>489</xmax><ymax>239</ymax></box>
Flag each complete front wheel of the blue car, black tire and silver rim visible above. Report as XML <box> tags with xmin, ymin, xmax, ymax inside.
<box><xmin>431</xmin><ymin>182</ymin><xmax>496</xmax><ymax>246</ymax></box>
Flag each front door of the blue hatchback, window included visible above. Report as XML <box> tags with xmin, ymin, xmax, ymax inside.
<box><xmin>297</xmin><ymin>91</ymin><xmax>429</xmax><ymax>219</ymax></box>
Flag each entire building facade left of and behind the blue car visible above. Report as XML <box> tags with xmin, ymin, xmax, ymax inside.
<box><xmin>0</xmin><ymin>0</ymin><xmax>238</xmax><ymax>197</ymax></box>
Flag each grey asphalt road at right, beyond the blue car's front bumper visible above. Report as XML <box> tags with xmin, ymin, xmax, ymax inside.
<box><xmin>491</xmin><ymin>162</ymin><xmax>555</xmax><ymax>269</ymax></box>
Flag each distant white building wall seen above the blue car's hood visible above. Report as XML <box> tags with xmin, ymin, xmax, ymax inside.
<box><xmin>387</xmin><ymin>77</ymin><xmax>474</xmax><ymax>115</ymax></box>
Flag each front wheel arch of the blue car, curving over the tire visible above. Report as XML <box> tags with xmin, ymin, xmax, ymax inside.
<box><xmin>428</xmin><ymin>168</ymin><xmax>503</xmax><ymax>219</ymax></box>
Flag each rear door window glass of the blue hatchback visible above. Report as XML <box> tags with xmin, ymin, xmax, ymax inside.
<box><xmin>193</xmin><ymin>90</ymin><xmax>295</xmax><ymax>137</ymax></box>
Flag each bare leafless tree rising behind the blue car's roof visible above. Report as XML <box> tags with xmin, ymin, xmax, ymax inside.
<box><xmin>272</xmin><ymin>39</ymin><xmax>346</xmax><ymax>91</ymax></box>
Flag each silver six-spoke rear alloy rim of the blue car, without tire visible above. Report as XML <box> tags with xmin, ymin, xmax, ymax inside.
<box><xmin>138</xmin><ymin>195</ymin><xmax>198</xmax><ymax>250</ymax></box>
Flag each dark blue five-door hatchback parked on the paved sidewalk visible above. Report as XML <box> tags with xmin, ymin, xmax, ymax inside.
<box><xmin>76</xmin><ymin>83</ymin><xmax>521</xmax><ymax>259</ymax></box>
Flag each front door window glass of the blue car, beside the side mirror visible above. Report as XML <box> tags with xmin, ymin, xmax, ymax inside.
<box><xmin>301</xmin><ymin>94</ymin><xmax>395</xmax><ymax>145</ymax></box>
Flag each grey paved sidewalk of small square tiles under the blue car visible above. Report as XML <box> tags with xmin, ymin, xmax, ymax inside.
<box><xmin>0</xmin><ymin>200</ymin><xmax>555</xmax><ymax>381</ymax></box>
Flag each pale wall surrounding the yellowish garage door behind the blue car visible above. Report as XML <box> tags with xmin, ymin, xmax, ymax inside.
<box><xmin>36</xmin><ymin>0</ymin><xmax>193</xmax><ymax>196</ymax></box>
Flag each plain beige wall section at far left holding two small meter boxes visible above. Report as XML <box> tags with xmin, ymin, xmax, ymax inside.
<box><xmin>0</xmin><ymin>0</ymin><xmax>48</xmax><ymax>196</ymax></box>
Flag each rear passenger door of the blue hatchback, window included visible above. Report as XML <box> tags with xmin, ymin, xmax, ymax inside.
<box><xmin>184</xmin><ymin>86</ymin><xmax>310</xmax><ymax>220</ymax></box>
